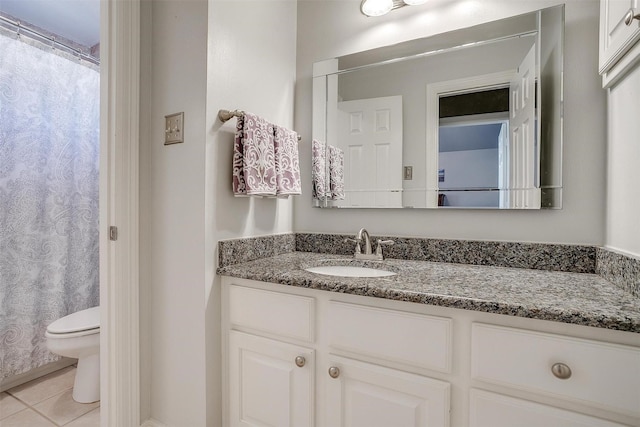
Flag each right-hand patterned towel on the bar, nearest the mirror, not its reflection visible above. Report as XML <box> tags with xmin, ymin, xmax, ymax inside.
<box><xmin>274</xmin><ymin>126</ymin><xmax>302</xmax><ymax>197</ymax></box>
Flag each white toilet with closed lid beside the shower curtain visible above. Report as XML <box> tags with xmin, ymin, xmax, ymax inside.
<box><xmin>45</xmin><ymin>307</ymin><xmax>100</xmax><ymax>403</ymax></box>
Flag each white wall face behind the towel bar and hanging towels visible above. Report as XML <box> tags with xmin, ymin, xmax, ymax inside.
<box><xmin>204</xmin><ymin>0</ymin><xmax>297</xmax><ymax>426</ymax></box>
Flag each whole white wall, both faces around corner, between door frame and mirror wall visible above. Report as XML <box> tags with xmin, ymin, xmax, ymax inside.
<box><xmin>140</xmin><ymin>0</ymin><xmax>296</xmax><ymax>427</ymax></box>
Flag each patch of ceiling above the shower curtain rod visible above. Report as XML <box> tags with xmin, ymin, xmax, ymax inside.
<box><xmin>0</xmin><ymin>0</ymin><xmax>100</xmax><ymax>47</ymax></box>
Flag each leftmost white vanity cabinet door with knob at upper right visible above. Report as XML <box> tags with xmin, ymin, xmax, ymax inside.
<box><xmin>228</xmin><ymin>331</ymin><xmax>315</xmax><ymax>427</ymax></box>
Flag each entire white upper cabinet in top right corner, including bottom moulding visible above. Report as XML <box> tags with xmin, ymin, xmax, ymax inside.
<box><xmin>599</xmin><ymin>0</ymin><xmax>640</xmax><ymax>87</ymax></box>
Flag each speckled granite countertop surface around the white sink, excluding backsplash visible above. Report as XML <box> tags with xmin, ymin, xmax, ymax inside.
<box><xmin>218</xmin><ymin>252</ymin><xmax>640</xmax><ymax>333</ymax></box>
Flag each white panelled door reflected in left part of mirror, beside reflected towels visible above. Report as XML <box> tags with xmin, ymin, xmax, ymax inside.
<box><xmin>336</xmin><ymin>96</ymin><xmax>403</xmax><ymax>208</ymax></box>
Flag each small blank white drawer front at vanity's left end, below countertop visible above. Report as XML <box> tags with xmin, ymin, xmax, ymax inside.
<box><xmin>228</xmin><ymin>285</ymin><xmax>315</xmax><ymax>342</ymax></box>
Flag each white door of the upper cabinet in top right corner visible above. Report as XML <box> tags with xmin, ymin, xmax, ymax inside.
<box><xmin>600</xmin><ymin>0</ymin><xmax>640</xmax><ymax>74</ymax></box>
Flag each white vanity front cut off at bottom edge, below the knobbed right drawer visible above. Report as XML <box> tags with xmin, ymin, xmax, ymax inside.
<box><xmin>469</xmin><ymin>389</ymin><xmax>623</xmax><ymax>427</ymax></box>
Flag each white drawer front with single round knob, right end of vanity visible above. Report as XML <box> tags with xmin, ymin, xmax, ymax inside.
<box><xmin>471</xmin><ymin>323</ymin><xmax>640</xmax><ymax>416</ymax></box>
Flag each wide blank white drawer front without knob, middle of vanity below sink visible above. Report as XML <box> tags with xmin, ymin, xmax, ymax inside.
<box><xmin>328</xmin><ymin>301</ymin><xmax>451</xmax><ymax>372</ymax></box>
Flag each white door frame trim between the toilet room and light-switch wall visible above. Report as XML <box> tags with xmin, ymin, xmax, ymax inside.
<box><xmin>100</xmin><ymin>0</ymin><xmax>140</xmax><ymax>427</ymax></box>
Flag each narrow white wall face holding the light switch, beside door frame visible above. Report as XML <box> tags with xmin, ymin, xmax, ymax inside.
<box><xmin>140</xmin><ymin>0</ymin><xmax>207</xmax><ymax>426</ymax></box>
